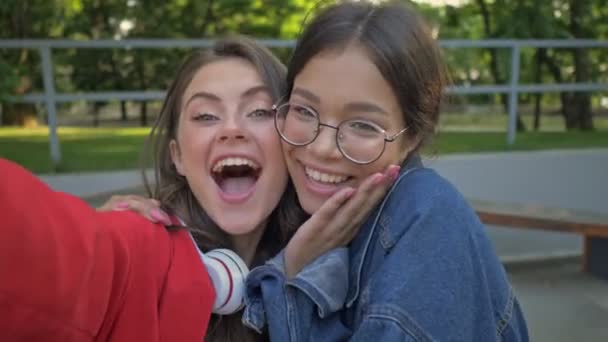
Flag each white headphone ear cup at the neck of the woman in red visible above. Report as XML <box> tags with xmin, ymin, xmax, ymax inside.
<box><xmin>203</xmin><ymin>248</ymin><xmax>249</xmax><ymax>315</ymax></box>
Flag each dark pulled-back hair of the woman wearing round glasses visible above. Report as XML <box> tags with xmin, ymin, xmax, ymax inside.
<box><xmin>287</xmin><ymin>2</ymin><xmax>446</xmax><ymax>147</ymax></box>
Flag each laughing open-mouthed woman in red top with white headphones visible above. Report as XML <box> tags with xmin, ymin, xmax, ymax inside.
<box><xmin>0</xmin><ymin>38</ymin><xmax>388</xmax><ymax>341</ymax></box>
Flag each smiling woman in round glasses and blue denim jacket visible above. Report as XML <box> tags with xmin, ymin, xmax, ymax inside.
<box><xmin>244</xmin><ymin>2</ymin><xmax>528</xmax><ymax>341</ymax></box>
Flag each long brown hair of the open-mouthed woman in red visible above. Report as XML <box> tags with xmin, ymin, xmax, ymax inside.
<box><xmin>143</xmin><ymin>37</ymin><xmax>304</xmax><ymax>341</ymax></box>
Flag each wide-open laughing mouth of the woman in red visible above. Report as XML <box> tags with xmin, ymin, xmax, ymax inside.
<box><xmin>211</xmin><ymin>158</ymin><xmax>262</xmax><ymax>196</ymax></box>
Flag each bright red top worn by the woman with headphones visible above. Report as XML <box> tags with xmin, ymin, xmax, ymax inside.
<box><xmin>0</xmin><ymin>159</ymin><xmax>215</xmax><ymax>342</ymax></box>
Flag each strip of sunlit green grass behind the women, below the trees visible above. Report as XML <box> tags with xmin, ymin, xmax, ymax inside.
<box><xmin>0</xmin><ymin>126</ymin><xmax>608</xmax><ymax>173</ymax></box>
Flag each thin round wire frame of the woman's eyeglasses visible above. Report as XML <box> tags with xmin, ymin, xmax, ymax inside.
<box><xmin>271</xmin><ymin>102</ymin><xmax>409</xmax><ymax>165</ymax></box>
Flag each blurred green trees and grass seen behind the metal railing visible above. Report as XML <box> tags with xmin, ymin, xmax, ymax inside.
<box><xmin>0</xmin><ymin>0</ymin><xmax>608</xmax><ymax>172</ymax></box>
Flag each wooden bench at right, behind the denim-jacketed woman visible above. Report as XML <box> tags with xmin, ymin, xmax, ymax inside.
<box><xmin>469</xmin><ymin>199</ymin><xmax>608</xmax><ymax>279</ymax></box>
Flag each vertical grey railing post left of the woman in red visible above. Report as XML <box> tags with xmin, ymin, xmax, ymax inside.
<box><xmin>40</xmin><ymin>45</ymin><xmax>61</xmax><ymax>167</ymax></box>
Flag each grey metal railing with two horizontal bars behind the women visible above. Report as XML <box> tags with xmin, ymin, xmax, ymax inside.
<box><xmin>0</xmin><ymin>39</ymin><xmax>608</xmax><ymax>165</ymax></box>
